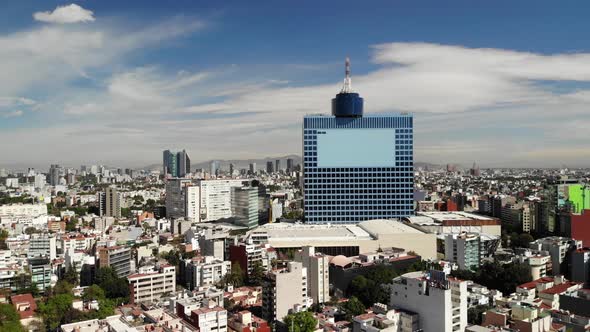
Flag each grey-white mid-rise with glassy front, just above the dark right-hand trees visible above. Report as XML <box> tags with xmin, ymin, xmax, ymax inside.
<box><xmin>445</xmin><ymin>233</ymin><xmax>483</xmax><ymax>270</ymax></box>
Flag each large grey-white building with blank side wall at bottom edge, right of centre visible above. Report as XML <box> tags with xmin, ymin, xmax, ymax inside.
<box><xmin>389</xmin><ymin>271</ymin><xmax>468</xmax><ymax>332</ymax></box>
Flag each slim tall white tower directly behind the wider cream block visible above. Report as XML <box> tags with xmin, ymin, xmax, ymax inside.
<box><xmin>295</xmin><ymin>246</ymin><xmax>330</xmax><ymax>303</ymax></box>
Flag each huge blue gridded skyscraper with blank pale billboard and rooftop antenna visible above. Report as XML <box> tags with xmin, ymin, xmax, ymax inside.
<box><xmin>303</xmin><ymin>60</ymin><xmax>414</xmax><ymax>223</ymax></box>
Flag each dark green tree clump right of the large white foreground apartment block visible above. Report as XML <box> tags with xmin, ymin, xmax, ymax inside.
<box><xmin>451</xmin><ymin>262</ymin><xmax>532</xmax><ymax>294</ymax></box>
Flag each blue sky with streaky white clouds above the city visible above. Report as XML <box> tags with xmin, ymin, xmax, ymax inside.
<box><xmin>0</xmin><ymin>0</ymin><xmax>590</xmax><ymax>167</ymax></box>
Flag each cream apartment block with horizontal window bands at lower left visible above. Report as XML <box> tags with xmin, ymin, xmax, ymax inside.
<box><xmin>127</xmin><ymin>265</ymin><xmax>176</xmax><ymax>303</ymax></box>
